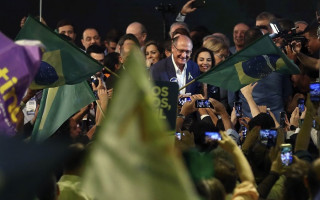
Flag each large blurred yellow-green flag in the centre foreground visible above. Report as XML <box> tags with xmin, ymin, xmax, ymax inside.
<box><xmin>83</xmin><ymin>48</ymin><xmax>198</xmax><ymax>200</ymax></box>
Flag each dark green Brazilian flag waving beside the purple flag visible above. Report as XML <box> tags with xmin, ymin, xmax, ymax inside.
<box><xmin>16</xmin><ymin>16</ymin><xmax>103</xmax><ymax>89</ymax></box>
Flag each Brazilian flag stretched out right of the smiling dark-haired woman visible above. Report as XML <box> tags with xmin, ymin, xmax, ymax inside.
<box><xmin>195</xmin><ymin>35</ymin><xmax>300</xmax><ymax>91</ymax></box>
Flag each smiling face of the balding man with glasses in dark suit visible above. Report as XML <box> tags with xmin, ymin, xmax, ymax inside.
<box><xmin>171</xmin><ymin>35</ymin><xmax>193</xmax><ymax>69</ymax></box>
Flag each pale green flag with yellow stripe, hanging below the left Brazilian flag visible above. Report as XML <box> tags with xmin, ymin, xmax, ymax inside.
<box><xmin>31</xmin><ymin>81</ymin><xmax>95</xmax><ymax>142</ymax></box>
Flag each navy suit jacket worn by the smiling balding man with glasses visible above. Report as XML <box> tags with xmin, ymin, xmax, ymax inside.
<box><xmin>150</xmin><ymin>56</ymin><xmax>201</xmax><ymax>94</ymax></box>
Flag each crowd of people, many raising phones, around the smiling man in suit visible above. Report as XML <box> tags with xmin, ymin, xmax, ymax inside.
<box><xmin>17</xmin><ymin>0</ymin><xmax>320</xmax><ymax>200</ymax></box>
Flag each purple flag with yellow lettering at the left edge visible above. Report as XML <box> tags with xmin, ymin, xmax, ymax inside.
<box><xmin>0</xmin><ymin>32</ymin><xmax>41</xmax><ymax>135</ymax></box>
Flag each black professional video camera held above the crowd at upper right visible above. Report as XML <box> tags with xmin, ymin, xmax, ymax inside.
<box><xmin>269</xmin><ymin>23</ymin><xmax>307</xmax><ymax>48</ymax></box>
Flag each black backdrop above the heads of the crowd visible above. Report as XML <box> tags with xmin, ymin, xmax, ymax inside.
<box><xmin>0</xmin><ymin>0</ymin><xmax>319</xmax><ymax>44</ymax></box>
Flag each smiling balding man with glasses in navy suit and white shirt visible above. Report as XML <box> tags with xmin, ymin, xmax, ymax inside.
<box><xmin>150</xmin><ymin>35</ymin><xmax>201</xmax><ymax>94</ymax></box>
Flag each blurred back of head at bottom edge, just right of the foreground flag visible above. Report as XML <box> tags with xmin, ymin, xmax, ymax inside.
<box><xmin>196</xmin><ymin>178</ymin><xmax>226</xmax><ymax>200</ymax></box>
